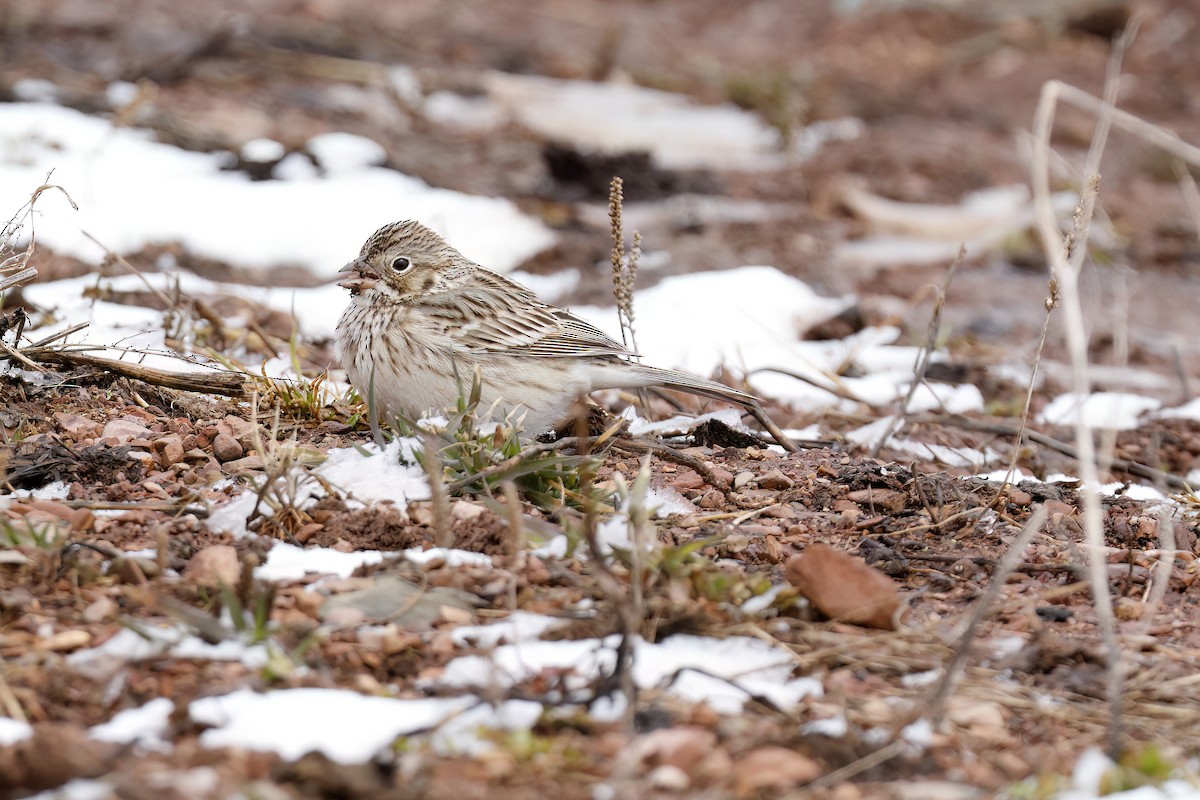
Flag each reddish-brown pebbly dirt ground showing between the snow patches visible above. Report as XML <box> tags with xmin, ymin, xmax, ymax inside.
<box><xmin>0</xmin><ymin>0</ymin><xmax>1200</xmax><ymax>800</ymax></box>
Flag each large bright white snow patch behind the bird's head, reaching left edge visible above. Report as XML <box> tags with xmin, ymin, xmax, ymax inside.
<box><xmin>0</xmin><ymin>103</ymin><xmax>553</xmax><ymax>277</ymax></box>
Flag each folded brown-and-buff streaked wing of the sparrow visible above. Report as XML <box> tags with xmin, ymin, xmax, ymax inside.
<box><xmin>421</xmin><ymin>269</ymin><xmax>631</xmax><ymax>359</ymax></box>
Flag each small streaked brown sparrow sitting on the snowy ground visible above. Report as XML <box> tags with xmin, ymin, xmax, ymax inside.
<box><xmin>336</xmin><ymin>219</ymin><xmax>758</xmax><ymax>434</ymax></box>
